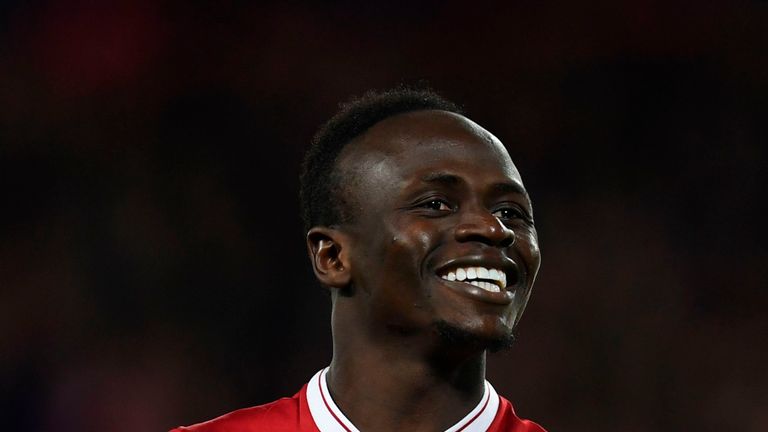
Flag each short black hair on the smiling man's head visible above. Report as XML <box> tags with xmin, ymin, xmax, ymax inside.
<box><xmin>299</xmin><ymin>86</ymin><xmax>463</xmax><ymax>233</ymax></box>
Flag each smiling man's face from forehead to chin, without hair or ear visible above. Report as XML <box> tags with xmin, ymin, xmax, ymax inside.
<box><xmin>337</xmin><ymin>111</ymin><xmax>540</xmax><ymax>348</ymax></box>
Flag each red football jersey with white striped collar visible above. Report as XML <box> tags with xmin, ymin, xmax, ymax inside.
<box><xmin>171</xmin><ymin>368</ymin><xmax>546</xmax><ymax>432</ymax></box>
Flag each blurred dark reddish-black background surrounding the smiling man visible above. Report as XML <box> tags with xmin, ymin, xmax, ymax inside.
<box><xmin>0</xmin><ymin>0</ymin><xmax>768</xmax><ymax>432</ymax></box>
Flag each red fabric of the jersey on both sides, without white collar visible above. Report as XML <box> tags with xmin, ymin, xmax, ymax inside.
<box><xmin>171</xmin><ymin>384</ymin><xmax>546</xmax><ymax>432</ymax></box>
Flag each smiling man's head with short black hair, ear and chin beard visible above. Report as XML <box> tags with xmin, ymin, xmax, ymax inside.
<box><xmin>301</xmin><ymin>90</ymin><xmax>540</xmax><ymax>349</ymax></box>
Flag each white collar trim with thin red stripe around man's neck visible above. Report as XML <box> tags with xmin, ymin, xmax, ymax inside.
<box><xmin>307</xmin><ymin>367</ymin><xmax>499</xmax><ymax>432</ymax></box>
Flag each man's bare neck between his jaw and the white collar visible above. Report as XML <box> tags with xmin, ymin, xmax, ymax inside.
<box><xmin>328</xmin><ymin>326</ymin><xmax>485</xmax><ymax>431</ymax></box>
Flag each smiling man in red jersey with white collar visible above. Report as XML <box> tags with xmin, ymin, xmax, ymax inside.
<box><xmin>176</xmin><ymin>89</ymin><xmax>544</xmax><ymax>432</ymax></box>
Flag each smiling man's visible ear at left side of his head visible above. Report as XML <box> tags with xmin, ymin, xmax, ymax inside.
<box><xmin>307</xmin><ymin>227</ymin><xmax>352</xmax><ymax>289</ymax></box>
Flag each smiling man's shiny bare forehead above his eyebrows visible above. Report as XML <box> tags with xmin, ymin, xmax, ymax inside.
<box><xmin>338</xmin><ymin>111</ymin><xmax>522</xmax><ymax>187</ymax></box>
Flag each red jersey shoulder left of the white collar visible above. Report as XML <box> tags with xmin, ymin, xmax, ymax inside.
<box><xmin>171</xmin><ymin>386</ymin><xmax>312</xmax><ymax>432</ymax></box>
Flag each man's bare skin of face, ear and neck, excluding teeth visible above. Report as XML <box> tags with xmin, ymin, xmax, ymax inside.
<box><xmin>307</xmin><ymin>111</ymin><xmax>541</xmax><ymax>432</ymax></box>
